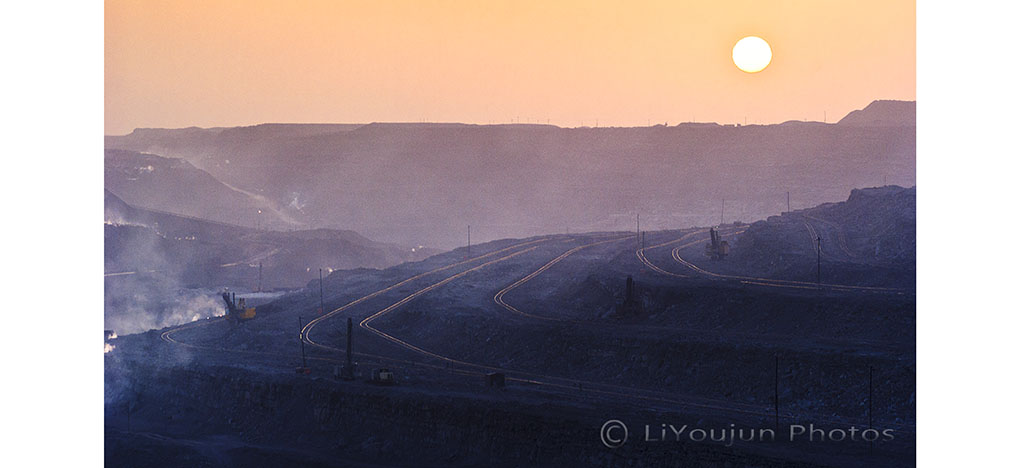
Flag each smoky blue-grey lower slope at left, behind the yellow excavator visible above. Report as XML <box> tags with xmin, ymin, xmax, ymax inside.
<box><xmin>103</xmin><ymin>190</ymin><xmax>436</xmax><ymax>334</ymax></box>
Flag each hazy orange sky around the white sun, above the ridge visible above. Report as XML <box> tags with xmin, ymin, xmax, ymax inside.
<box><xmin>104</xmin><ymin>0</ymin><xmax>915</xmax><ymax>134</ymax></box>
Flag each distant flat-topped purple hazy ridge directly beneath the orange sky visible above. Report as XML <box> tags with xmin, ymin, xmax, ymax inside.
<box><xmin>106</xmin><ymin>101</ymin><xmax>915</xmax><ymax>248</ymax></box>
